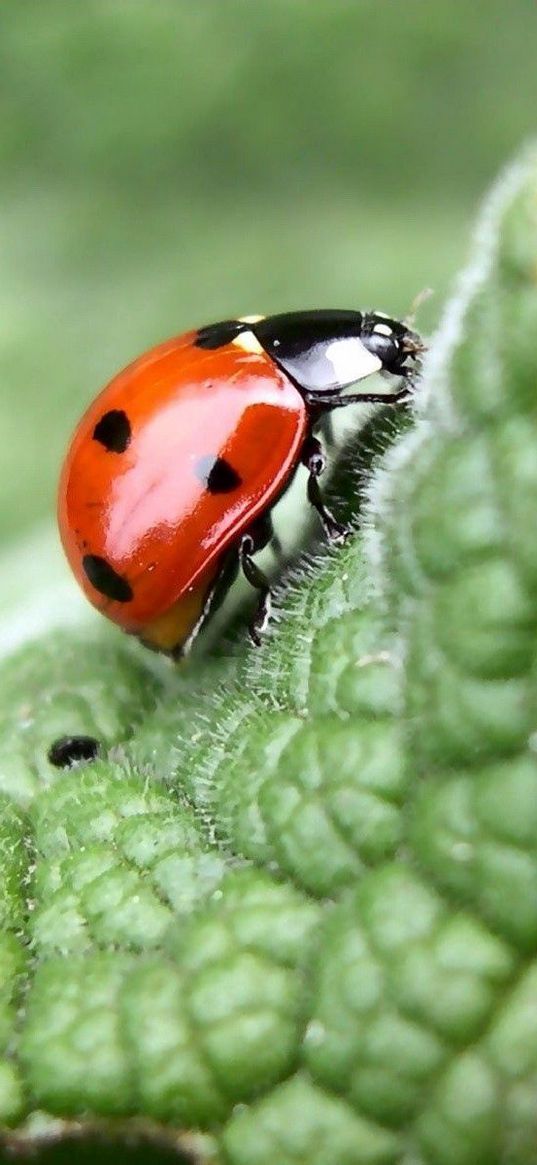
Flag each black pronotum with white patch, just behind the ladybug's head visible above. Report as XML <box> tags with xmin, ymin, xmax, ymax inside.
<box><xmin>253</xmin><ymin>311</ymin><xmax>382</xmax><ymax>393</ymax></box>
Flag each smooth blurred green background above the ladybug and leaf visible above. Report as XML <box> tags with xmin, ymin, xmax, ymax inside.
<box><xmin>0</xmin><ymin>0</ymin><xmax>537</xmax><ymax>553</ymax></box>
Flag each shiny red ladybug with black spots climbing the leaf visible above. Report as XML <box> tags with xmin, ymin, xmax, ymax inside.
<box><xmin>58</xmin><ymin>310</ymin><xmax>423</xmax><ymax>656</ymax></box>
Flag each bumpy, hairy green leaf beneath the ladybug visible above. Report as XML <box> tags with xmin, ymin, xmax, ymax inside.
<box><xmin>0</xmin><ymin>153</ymin><xmax>537</xmax><ymax>1165</ymax></box>
